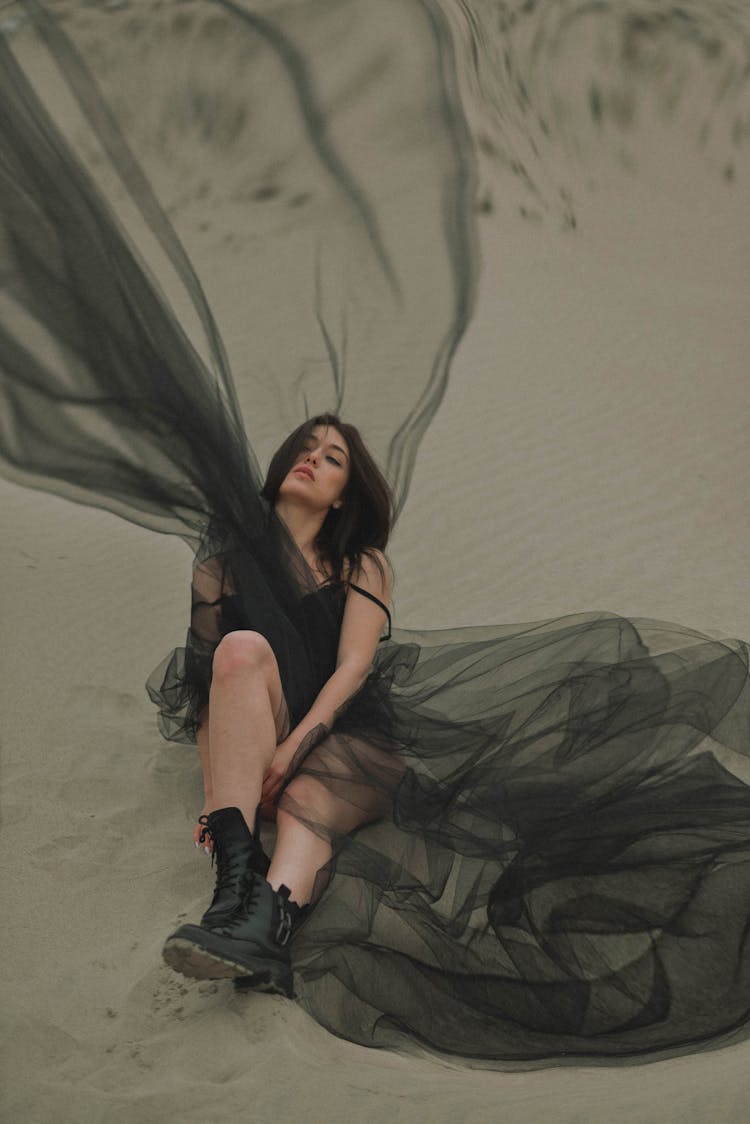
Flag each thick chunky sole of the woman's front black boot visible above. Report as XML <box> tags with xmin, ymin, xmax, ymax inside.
<box><xmin>162</xmin><ymin>926</ymin><xmax>293</xmax><ymax>999</ymax></box>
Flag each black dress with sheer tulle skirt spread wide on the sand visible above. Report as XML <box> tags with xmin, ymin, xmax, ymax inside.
<box><xmin>150</xmin><ymin>516</ymin><xmax>750</xmax><ymax>1059</ymax></box>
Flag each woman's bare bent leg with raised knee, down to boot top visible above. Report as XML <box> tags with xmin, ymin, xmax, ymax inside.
<box><xmin>198</xmin><ymin>631</ymin><xmax>286</xmax><ymax>831</ymax></box>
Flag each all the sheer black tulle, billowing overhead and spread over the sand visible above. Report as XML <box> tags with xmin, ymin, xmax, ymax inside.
<box><xmin>0</xmin><ymin>0</ymin><xmax>750</xmax><ymax>1060</ymax></box>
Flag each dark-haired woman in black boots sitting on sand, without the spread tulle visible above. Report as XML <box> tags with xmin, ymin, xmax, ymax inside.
<box><xmin>164</xmin><ymin>415</ymin><xmax>390</xmax><ymax>994</ymax></box>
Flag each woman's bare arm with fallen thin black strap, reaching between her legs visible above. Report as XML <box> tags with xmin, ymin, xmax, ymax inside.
<box><xmin>262</xmin><ymin>554</ymin><xmax>390</xmax><ymax>804</ymax></box>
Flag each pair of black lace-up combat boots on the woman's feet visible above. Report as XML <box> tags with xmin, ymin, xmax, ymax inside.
<box><xmin>163</xmin><ymin>808</ymin><xmax>295</xmax><ymax>996</ymax></box>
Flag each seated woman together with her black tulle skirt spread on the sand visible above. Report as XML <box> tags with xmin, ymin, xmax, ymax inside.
<box><xmin>152</xmin><ymin>415</ymin><xmax>750</xmax><ymax>1057</ymax></box>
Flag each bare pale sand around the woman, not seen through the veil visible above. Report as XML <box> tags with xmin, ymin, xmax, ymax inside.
<box><xmin>0</xmin><ymin>4</ymin><xmax>750</xmax><ymax>1124</ymax></box>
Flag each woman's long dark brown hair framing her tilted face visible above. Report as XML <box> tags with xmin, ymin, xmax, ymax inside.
<box><xmin>262</xmin><ymin>414</ymin><xmax>394</xmax><ymax>580</ymax></box>
